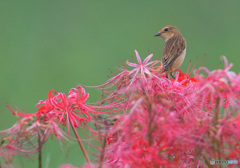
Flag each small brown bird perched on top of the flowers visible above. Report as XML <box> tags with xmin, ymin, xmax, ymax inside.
<box><xmin>155</xmin><ymin>25</ymin><xmax>186</xmax><ymax>77</ymax></box>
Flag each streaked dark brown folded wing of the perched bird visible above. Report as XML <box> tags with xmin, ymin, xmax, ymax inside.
<box><xmin>162</xmin><ymin>36</ymin><xmax>186</xmax><ymax>71</ymax></box>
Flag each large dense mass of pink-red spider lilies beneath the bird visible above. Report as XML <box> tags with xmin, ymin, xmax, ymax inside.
<box><xmin>89</xmin><ymin>53</ymin><xmax>240</xmax><ymax>167</ymax></box>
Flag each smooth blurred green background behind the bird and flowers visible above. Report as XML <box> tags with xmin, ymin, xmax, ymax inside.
<box><xmin>0</xmin><ymin>0</ymin><xmax>240</xmax><ymax>168</ymax></box>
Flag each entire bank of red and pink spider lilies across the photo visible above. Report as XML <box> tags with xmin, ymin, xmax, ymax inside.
<box><xmin>0</xmin><ymin>50</ymin><xmax>240</xmax><ymax>168</ymax></box>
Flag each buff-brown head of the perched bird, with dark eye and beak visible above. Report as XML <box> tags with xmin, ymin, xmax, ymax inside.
<box><xmin>154</xmin><ymin>25</ymin><xmax>179</xmax><ymax>41</ymax></box>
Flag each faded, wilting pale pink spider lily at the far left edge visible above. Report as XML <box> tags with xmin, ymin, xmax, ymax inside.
<box><xmin>0</xmin><ymin>117</ymin><xmax>68</xmax><ymax>163</ymax></box>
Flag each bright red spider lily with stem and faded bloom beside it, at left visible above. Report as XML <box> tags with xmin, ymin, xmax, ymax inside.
<box><xmin>0</xmin><ymin>86</ymin><xmax>101</xmax><ymax>165</ymax></box>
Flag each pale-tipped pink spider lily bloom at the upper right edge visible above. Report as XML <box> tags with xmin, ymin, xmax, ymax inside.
<box><xmin>189</xmin><ymin>57</ymin><xmax>240</xmax><ymax>110</ymax></box>
